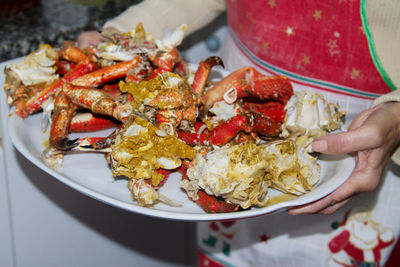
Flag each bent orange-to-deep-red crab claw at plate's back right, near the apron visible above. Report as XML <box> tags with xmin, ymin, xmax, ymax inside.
<box><xmin>200</xmin><ymin>67</ymin><xmax>293</xmax><ymax>138</ymax></box>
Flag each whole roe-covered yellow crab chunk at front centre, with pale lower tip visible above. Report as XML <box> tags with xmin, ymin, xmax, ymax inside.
<box><xmin>109</xmin><ymin>117</ymin><xmax>196</xmax><ymax>205</ymax></box>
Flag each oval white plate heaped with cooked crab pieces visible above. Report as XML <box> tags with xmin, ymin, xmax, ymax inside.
<box><xmin>4</xmin><ymin>23</ymin><xmax>354</xmax><ymax>221</ymax></box>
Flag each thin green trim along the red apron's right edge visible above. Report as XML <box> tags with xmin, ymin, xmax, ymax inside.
<box><xmin>360</xmin><ymin>0</ymin><xmax>396</xmax><ymax>91</ymax></box>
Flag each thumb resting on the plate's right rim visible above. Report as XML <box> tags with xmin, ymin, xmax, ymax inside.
<box><xmin>312</xmin><ymin>125</ymin><xmax>381</xmax><ymax>154</ymax></box>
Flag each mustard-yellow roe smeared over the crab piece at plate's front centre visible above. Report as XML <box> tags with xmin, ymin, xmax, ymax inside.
<box><xmin>111</xmin><ymin>117</ymin><xmax>196</xmax><ymax>186</ymax></box>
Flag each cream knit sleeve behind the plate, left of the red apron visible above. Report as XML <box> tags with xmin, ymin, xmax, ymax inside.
<box><xmin>103</xmin><ymin>0</ymin><xmax>225</xmax><ymax>39</ymax></box>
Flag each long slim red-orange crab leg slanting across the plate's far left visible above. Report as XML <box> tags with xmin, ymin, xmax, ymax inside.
<box><xmin>15</xmin><ymin>62</ymin><xmax>96</xmax><ymax>118</ymax></box>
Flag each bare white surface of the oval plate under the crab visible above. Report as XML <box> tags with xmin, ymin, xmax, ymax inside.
<box><xmin>1</xmin><ymin>61</ymin><xmax>354</xmax><ymax>221</ymax></box>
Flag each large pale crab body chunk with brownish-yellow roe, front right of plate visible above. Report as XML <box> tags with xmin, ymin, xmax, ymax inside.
<box><xmin>181</xmin><ymin>139</ymin><xmax>319</xmax><ymax>209</ymax></box>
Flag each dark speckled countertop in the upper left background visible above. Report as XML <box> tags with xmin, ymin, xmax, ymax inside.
<box><xmin>0</xmin><ymin>0</ymin><xmax>140</xmax><ymax>62</ymax></box>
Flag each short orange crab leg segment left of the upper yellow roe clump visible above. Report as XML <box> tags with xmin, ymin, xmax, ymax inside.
<box><xmin>71</xmin><ymin>55</ymin><xmax>145</xmax><ymax>87</ymax></box>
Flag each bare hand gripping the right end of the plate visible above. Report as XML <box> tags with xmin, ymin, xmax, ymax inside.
<box><xmin>289</xmin><ymin>102</ymin><xmax>400</xmax><ymax>215</ymax></box>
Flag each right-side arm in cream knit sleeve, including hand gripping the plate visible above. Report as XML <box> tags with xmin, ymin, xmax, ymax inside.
<box><xmin>289</xmin><ymin>0</ymin><xmax>400</xmax><ymax>215</ymax></box>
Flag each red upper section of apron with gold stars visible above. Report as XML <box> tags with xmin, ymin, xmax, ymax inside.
<box><xmin>227</xmin><ymin>0</ymin><xmax>391</xmax><ymax>99</ymax></box>
